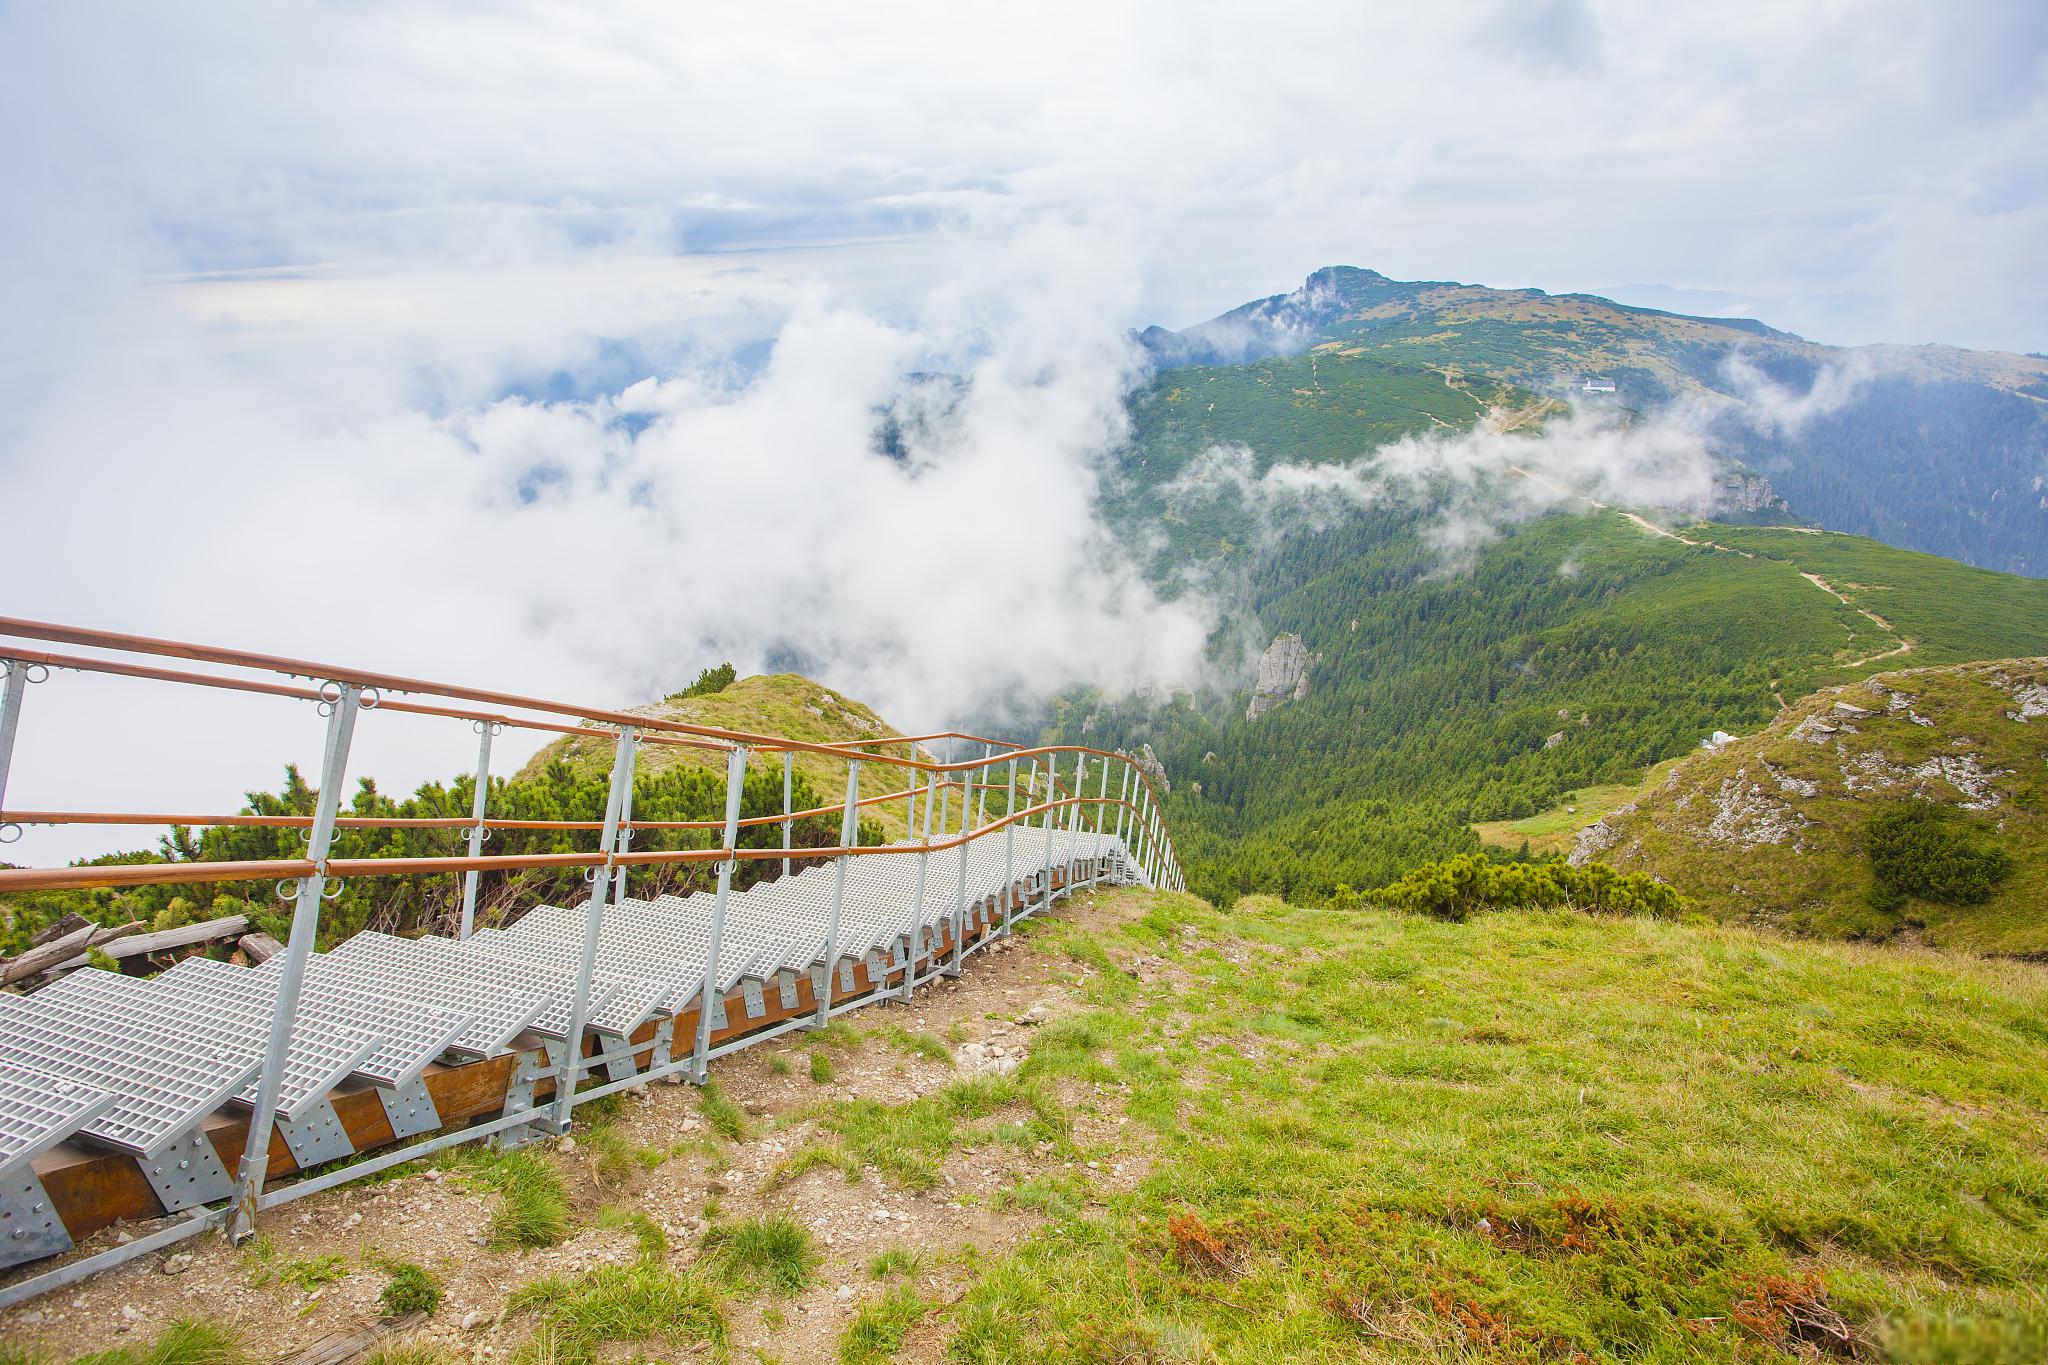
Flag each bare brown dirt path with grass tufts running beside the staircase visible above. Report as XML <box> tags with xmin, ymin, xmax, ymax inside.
<box><xmin>0</xmin><ymin>894</ymin><xmax>1145</xmax><ymax>1363</ymax></box>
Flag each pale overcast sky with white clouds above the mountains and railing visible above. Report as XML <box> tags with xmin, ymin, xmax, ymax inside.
<box><xmin>0</xmin><ymin>0</ymin><xmax>2048</xmax><ymax>855</ymax></box>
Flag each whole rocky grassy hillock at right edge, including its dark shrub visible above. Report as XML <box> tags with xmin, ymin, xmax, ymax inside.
<box><xmin>1573</xmin><ymin>659</ymin><xmax>2048</xmax><ymax>956</ymax></box>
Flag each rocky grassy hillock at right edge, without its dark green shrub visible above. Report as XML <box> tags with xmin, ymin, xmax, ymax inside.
<box><xmin>1599</xmin><ymin>654</ymin><xmax>2048</xmax><ymax>954</ymax></box>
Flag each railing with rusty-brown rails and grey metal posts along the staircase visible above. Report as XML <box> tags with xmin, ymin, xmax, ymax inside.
<box><xmin>0</xmin><ymin>618</ymin><xmax>1186</xmax><ymax>1302</ymax></box>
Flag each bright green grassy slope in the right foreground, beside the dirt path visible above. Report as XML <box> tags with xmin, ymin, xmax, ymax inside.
<box><xmin>937</xmin><ymin>892</ymin><xmax>2048</xmax><ymax>1361</ymax></box>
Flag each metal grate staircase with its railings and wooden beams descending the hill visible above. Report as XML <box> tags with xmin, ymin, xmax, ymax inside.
<box><xmin>0</xmin><ymin>618</ymin><xmax>1182</xmax><ymax>1306</ymax></box>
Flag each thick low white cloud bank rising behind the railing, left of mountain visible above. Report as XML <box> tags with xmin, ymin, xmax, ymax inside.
<box><xmin>8</xmin><ymin>231</ymin><xmax>1210</xmax><ymax>855</ymax></box>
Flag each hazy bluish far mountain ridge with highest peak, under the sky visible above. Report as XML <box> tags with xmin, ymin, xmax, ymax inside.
<box><xmin>1135</xmin><ymin>266</ymin><xmax>2048</xmax><ymax>577</ymax></box>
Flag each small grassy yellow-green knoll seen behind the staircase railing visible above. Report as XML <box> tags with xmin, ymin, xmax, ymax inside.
<box><xmin>520</xmin><ymin>673</ymin><xmax>929</xmax><ymax>839</ymax></box>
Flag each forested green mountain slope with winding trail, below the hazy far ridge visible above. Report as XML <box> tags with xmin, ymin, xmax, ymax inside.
<box><xmin>1057</xmin><ymin>505</ymin><xmax>2048</xmax><ymax>898</ymax></box>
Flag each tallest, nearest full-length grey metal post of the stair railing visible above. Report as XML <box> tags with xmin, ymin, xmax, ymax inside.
<box><xmin>230</xmin><ymin>675</ymin><xmax>362</xmax><ymax>1242</ymax></box>
